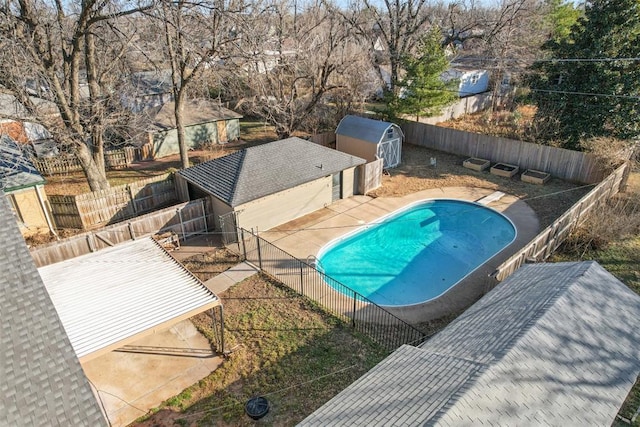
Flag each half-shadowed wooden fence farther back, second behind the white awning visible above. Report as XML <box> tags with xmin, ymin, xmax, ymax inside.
<box><xmin>49</xmin><ymin>174</ymin><xmax>177</xmax><ymax>229</ymax></box>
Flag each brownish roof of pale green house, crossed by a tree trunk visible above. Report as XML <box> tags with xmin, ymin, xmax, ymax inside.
<box><xmin>148</xmin><ymin>99</ymin><xmax>242</xmax><ymax>130</ymax></box>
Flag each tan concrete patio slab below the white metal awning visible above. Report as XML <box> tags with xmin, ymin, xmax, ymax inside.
<box><xmin>82</xmin><ymin>320</ymin><xmax>222</xmax><ymax>427</ymax></box>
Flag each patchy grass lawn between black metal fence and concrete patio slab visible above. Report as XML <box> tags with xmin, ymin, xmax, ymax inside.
<box><xmin>139</xmin><ymin>275</ymin><xmax>386</xmax><ymax>426</ymax></box>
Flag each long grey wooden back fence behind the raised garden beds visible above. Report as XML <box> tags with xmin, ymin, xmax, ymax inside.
<box><xmin>401</xmin><ymin>122</ymin><xmax>605</xmax><ymax>184</ymax></box>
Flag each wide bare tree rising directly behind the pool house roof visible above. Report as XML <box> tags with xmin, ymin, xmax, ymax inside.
<box><xmin>233</xmin><ymin>2</ymin><xmax>362</xmax><ymax>138</ymax></box>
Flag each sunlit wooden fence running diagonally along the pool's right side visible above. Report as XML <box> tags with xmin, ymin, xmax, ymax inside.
<box><xmin>494</xmin><ymin>164</ymin><xmax>629</xmax><ymax>281</ymax></box>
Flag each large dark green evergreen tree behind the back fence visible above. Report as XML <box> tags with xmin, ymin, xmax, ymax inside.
<box><xmin>530</xmin><ymin>0</ymin><xmax>640</xmax><ymax>149</ymax></box>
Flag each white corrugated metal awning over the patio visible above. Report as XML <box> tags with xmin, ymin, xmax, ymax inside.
<box><xmin>38</xmin><ymin>237</ymin><xmax>222</xmax><ymax>362</ymax></box>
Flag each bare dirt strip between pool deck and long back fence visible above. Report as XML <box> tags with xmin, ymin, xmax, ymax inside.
<box><xmin>369</xmin><ymin>143</ymin><xmax>594</xmax><ymax>227</ymax></box>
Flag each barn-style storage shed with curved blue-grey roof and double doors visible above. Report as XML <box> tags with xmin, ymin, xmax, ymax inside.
<box><xmin>336</xmin><ymin>116</ymin><xmax>404</xmax><ymax>169</ymax></box>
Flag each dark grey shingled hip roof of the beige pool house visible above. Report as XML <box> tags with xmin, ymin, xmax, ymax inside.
<box><xmin>178</xmin><ymin>137</ymin><xmax>365</xmax><ymax>207</ymax></box>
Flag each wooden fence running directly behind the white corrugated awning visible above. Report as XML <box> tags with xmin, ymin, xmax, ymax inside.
<box><xmin>31</xmin><ymin>199</ymin><xmax>213</xmax><ymax>267</ymax></box>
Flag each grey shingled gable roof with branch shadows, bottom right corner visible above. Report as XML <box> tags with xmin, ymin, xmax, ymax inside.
<box><xmin>301</xmin><ymin>262</ymin><xmax>640</xmax><ymax>426</ymax></box>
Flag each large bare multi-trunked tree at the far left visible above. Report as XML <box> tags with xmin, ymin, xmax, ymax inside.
<box><xmin>0</xmin><ymin>0</ymin><xmax>149</xmax><ymax>190</ymax></box>
